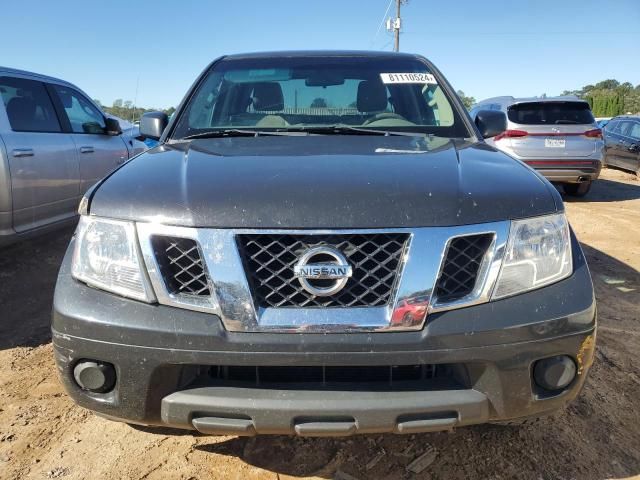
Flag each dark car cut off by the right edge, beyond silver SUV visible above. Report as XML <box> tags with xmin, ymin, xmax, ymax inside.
<box><xmin>604</xmin><ymin>116</ymin><xmax>640</xmax><ymax>175</ymax></box>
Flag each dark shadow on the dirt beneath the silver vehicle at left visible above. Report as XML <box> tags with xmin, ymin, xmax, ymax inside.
<box><xmin>0</xmin><ymin>227</ymin><xmax>73</xmax><ymax>350</ymax></box>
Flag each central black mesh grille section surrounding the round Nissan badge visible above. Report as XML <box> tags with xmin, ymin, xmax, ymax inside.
<box><xmin>237</xmin><ymin>233</ymin><xmax>409</xmax><ymax>308</ymax></box>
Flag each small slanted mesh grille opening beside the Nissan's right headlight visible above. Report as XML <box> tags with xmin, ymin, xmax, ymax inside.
<box><xmin>435</xmin><ymin>234</ymin><xmax>493</xmax><ymax>303</ymax></box>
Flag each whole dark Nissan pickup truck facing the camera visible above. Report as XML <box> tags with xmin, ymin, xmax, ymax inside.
<box><xmin>53</xmin><ymin>52</ymin><xmax>596</xmax><ymax>436</ymax></box>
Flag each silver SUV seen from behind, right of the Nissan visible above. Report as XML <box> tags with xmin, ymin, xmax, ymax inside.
<box><xmin>470</xmin><ymin>96</ymin><xmax>604</xmax><ymax>197</ymax></box>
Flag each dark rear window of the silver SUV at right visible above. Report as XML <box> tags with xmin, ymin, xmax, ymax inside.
<box><xmin>508</xmin><ymin>102</ymin><xmax>595</xmax><ymax>125</ymax></box>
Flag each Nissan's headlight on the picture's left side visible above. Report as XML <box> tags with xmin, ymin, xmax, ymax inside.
<box><xmin>71</xmin><ymin>216</ymin><xmax>154</xmax><ymax>302</ymax></box>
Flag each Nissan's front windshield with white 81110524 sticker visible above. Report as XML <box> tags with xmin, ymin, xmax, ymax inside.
<box><xmin>172</xmin><ymin>56</ymin><xmax>469</xmax><ymax>138</ymax></box>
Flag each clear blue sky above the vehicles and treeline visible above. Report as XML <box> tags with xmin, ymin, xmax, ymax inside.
<box><xmin>0</xmin><ymin>0</ymin><xmax>640</xmax><ymax>107</ymax></box>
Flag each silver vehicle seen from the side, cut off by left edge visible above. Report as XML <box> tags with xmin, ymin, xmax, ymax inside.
<box><xmin>0</xmin><ymin>67</ymin><xmax>144</xmax><ymax>245</ymax></box>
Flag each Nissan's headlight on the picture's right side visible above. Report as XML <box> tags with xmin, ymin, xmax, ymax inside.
<box><xmin>492</xmin><ymin>213</ymin><xmax>573</xmax><ymax>299</ymax></box>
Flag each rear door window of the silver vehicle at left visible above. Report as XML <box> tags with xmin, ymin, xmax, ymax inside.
<box><xmin>0</xmin><ymin>77</ymin><xmax>61</xmax><ymax>132</ymax></box>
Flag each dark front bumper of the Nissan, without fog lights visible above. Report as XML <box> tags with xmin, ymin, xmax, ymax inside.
<box><xmin>53</xmin><ymin>234</ymin><xmax>596</xmax><ymax>435</ymax></box>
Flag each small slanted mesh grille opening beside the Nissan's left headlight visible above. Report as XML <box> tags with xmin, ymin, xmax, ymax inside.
<box><xmin>151</xmin><ymin>236</ymin><xmax>211</xmax><ymax>297</ymax></box>
